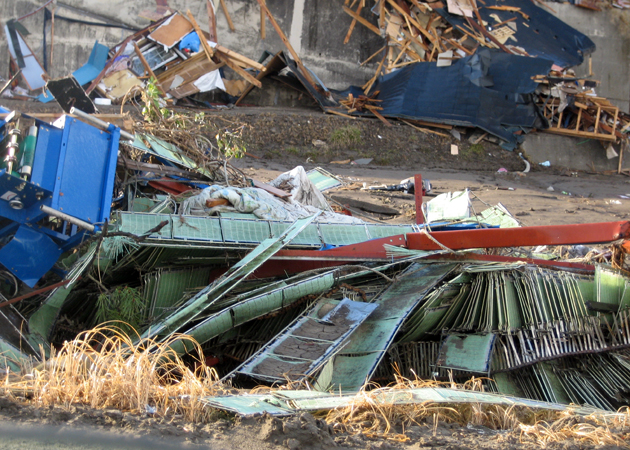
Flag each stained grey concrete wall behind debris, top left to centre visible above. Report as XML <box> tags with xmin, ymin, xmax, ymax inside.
<box><xmin>0</xmin><ymin>0</ymin><xmax>382</xmax><ymax>89</ymax></box>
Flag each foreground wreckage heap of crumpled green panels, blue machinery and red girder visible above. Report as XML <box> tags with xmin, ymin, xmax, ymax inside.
<box><xmin>0</xmin><ymin>98</ymin><xmax>630</xmax><ymax>415</ymax></box>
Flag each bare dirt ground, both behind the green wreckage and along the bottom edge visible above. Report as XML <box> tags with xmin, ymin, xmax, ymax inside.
<box><xmin>0</xmin><ymin>100</ymin><xmax>630</xmax><ymax>450</ymax></box>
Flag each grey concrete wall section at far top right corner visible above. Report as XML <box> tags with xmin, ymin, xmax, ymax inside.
<box><xmin>549</xmin><ymin>3</ymin><xmax>630</xmax><ymax>112</ymax></box>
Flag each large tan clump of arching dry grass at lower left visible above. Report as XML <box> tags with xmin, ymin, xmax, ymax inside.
<box><xmin>0</xmin><ymin>327</ymin><xmax>223</xmax><ymax>422</ymax></box>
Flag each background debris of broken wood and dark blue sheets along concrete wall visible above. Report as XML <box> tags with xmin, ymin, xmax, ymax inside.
<box><xmin>5</xmin><ymin>0</ymin><xmax>630</xmax><ymax>166</ymax></box>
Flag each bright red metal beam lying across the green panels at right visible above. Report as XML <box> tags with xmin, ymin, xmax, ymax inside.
<box><xmin>407</xmin><ymin>221</ymin><xmax>630</xmax><ymax>250</ymax></box>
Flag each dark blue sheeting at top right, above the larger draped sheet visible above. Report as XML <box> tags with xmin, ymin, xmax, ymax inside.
<box><xmin>435</xmin><ymin>0</ymin><xmax>595</xmax><ymax>69</ymax></box>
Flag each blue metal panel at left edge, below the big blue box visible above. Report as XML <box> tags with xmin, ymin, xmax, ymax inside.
<box><xmin>0</xmin><ymin>225</ymin><xmax>61</xmax><ymax>288</ymax></box>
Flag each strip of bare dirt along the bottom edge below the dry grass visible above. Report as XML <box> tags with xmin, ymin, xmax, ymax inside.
<box><xmin>0</xmin><ymin>397</ymin><xmax>629</xmax><ymax>450</ymax></box>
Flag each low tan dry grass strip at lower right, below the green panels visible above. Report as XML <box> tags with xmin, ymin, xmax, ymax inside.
<box><xmin>326</xmin><ymin>370</ymin><xmax>630</xmax><ymax>447</ymax></box>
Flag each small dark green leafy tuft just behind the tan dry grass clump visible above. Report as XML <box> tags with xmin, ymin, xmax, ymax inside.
<box><xmin>94</xmin><ymin>286</ymin><xmax>145</xmax><ymax>336</ymax></box>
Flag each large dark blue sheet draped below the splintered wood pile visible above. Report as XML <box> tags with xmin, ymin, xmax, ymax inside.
<box><xmin>374</xmin><ymin>49</ymin><xmax>552</xmax><ymax>144</ymax></box>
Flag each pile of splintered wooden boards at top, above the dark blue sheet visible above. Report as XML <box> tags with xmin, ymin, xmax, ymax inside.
<box><xmin>342</xmin><ymin>0</ymin><xmax>529</xmax><ymax>78</ymax></box>
